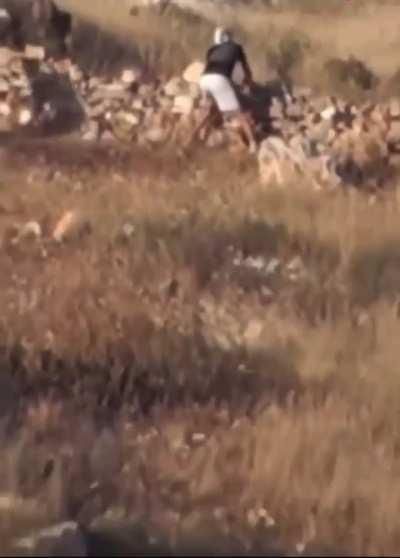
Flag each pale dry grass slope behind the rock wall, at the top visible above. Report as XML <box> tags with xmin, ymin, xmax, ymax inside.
<box><xmin>60</xmin><ymin>0</ymin><xmax>400</xmax><ymax>91</ymax></box>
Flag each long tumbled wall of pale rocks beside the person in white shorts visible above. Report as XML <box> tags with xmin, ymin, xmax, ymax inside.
<box><xmin>0</xmin><ymin>46</ymin><xmax>400</xmax><ymax>187</ymax></box>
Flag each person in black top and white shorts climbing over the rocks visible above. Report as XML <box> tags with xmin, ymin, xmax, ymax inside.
<box><xmin>191</xmin><ymin>27</ymin><xmax>257</xmax><ymax>153</ymax></box>
